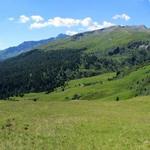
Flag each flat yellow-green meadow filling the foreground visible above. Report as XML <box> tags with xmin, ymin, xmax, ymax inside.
<box><xmin>0</xmin><ymin>97</ymin><xmax>150</xmax><ymax>150</ymax></box>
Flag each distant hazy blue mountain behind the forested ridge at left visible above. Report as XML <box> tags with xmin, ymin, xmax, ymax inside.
<box><xmin>0</xmin><ymin>34</ymin><xmax>68</xmax><ymax>61</ymax></box>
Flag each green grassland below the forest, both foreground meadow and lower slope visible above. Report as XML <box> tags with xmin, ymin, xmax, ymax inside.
<box><xmin>0</xmin><ymin>63</ymin><xmax>150</xmax><ymax>150</ymax></box>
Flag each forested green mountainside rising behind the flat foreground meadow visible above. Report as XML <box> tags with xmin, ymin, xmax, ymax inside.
<box><xmin>0</xmin><ymin>26</ymin><xmax>150</xmax><ymax>100</ymax></box>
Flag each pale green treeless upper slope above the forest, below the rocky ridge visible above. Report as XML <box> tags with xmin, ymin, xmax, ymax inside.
<box><xmin>41</xmin><ymin>26</ymin><xmax>150</xmax><ymax>52</ymax></box>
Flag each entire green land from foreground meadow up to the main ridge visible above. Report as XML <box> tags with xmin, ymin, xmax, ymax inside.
<box><xmin>0</xmin><ymin>26</ymin><xmax>150</xmax><ymax>150</ymax></box>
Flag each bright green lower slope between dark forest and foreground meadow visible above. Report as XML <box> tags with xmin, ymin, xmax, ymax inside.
<box><xmin>15</xmin><ymin>65</ymin><xmax>150</xmax><ymax>101</ymax></box>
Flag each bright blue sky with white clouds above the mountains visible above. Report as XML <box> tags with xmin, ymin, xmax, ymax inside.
<box><xmin>0</xmin><ymin>0</ymin><xmax>150</xmax><ymax>49</ymax></box>
